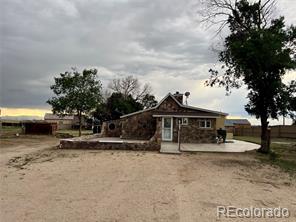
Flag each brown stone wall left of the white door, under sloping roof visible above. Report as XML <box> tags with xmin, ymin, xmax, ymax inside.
<box><xmin>121</xmin><ymin>111</ymin><xmax>156</xmax><ymax>140</ymax></box>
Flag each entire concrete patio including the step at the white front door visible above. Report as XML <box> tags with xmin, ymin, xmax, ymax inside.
<box><xmin>160</xmin><ymin>140</ymin><xmax>260</xmax><ymax>154</ymax></box>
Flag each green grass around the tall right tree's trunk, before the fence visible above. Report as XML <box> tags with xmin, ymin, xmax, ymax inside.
<box><xmin>234</xmin><ymin>136</ymin><xmax>296</xmax><ymax>175</ymax></box>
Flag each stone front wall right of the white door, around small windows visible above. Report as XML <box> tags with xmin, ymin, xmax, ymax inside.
<box><xmin>179</xmin><ymin>118</ymin><xmax>216</xmax><ymax>143</ymax></box>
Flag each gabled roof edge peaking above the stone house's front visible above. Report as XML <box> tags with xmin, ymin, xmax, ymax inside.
<box><xmin>120</xmin><ymin>93</ymin><xmax>228</xmax><ymax>118</ymax></box>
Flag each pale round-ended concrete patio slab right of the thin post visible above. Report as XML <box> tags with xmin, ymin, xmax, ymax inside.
<box><xmin>181</xmin><ymin>140</ymin><xmax>260</xmax><ymax>153</ymax></box>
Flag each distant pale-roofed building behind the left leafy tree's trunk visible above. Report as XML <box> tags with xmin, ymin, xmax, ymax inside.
<box><xmin>44</xmin><ymin>113</ymin><xmax>85</xmax><ymax>130</ymax></box>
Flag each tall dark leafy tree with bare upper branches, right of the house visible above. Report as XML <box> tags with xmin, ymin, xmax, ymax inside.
<box><xmin>203</xmin><ymin>0</ymin><xmax>296</xmax><ymax>153</ymax></box>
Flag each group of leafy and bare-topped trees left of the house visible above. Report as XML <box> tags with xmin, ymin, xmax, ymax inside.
<box><xmin>47</xmin><ymin>68</ymin><xmax>157</xmax><ymax>136</ymax></box>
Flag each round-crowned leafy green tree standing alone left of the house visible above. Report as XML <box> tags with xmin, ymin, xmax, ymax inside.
<box><xmin>47</xmin><ymin>69</ymin><xmax>102</xmax><ymax>136</ymax></box>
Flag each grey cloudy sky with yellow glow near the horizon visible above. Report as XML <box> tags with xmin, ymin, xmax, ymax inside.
<box><xmin>0</xmin><ymin>0</ymin><xmax>296</xmax><ymax>123</ymax></box>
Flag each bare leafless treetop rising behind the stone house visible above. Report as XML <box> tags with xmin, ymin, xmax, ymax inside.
<box><xmin>109</xmin><ymin>76</ymin><xmax>152</xmax><ymax>102</ymax></box>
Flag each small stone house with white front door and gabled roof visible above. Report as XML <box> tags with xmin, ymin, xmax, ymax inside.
<box><xmin>101</xmin><ymin>92</ymin><xmax>228</xmax><ymax>143</ymax></box>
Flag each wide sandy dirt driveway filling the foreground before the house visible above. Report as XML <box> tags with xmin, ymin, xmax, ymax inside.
<box><xmin>0</xmin><ymin>134</ymin><xmax>296</xmax><ymax>222</ymax></box>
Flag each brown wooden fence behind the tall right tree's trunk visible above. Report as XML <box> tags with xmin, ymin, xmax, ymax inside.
<box><xmin>234</xmin><ymin>125</ymin><xmax>296</xmax><ymax>139</ymax></box>
